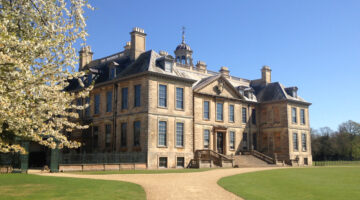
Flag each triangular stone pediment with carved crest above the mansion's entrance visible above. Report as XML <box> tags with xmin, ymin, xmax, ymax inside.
<box><xmin>194</xmin><ymin>76</ymin><xmax>244</xmax><ymax>99</ymax></box>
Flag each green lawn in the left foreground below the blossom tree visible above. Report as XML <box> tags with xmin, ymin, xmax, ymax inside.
<box><xmin>0</xmin><ymin>174</ymin><xmax>146</xmax><ymax>200</ymax></box>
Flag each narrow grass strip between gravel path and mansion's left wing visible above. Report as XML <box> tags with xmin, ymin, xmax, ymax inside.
<box><xmin>71</xmin><ymin>168</ymin><xmax>211</xmax><ymax>174</ymax></box>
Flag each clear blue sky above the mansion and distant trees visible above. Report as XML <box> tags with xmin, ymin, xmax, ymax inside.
<box><xmin>81</xmin><ymin>0</ymin><xmax>360</xmax><ymax>129</ymax></box>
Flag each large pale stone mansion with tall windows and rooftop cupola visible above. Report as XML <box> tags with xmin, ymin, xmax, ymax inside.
<box><xmin>69</xmin><ymin>28</ymin><xmax>312</xmax><ymax>169</ymax></box>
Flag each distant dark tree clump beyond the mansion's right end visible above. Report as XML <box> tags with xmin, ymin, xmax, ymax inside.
<box><xmin>311</xmin><ymin>120</ymin><xmax>360</xmax><ymax>161</ymax></box>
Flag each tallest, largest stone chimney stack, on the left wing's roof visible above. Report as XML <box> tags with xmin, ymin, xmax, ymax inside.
<box><xmin>130</xmin><ymin>27</ymin><xmax>146</xmax><ymax>60</ymax></box>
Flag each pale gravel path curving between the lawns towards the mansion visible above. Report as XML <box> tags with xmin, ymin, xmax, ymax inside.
<box><xmin>41</xmin><ymin>167</ymin><xmax>276</xmax><ymax>200</ymax></box>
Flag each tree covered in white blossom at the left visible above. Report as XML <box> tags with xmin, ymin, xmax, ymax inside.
<box><xmin>0</xmin><ymin>0</ymin><xmax>92</xmax><ymax>153</ymax></box>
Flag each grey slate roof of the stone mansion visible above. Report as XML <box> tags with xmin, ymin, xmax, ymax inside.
<box><xmin>66</xmin><ymin>50</ymin><xmax>310</xmax><ymax>104</ymax></box>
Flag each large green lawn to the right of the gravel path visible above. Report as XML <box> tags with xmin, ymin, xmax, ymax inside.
<box><xmin>218</xmin><ymin>167</ymin><xmax>360</xmax><ymax>200</ymax></box>
